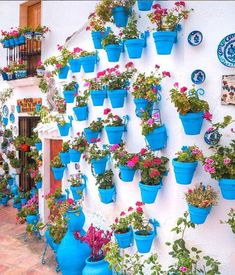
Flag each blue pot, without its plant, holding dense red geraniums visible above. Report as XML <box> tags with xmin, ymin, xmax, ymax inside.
<box><xmin>139</xmin><ymin>181</ymin><xmax>162</xmax><ymax>204</ymax></box>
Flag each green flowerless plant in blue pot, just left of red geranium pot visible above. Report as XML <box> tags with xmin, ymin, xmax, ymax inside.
<box><xmin>96</xmin><ymin>170</ymin><xmax>115</xmax><ymax>204</ymax></box>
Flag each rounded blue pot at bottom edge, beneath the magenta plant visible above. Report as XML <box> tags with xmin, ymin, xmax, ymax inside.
<box><xmin>82</xmin><ymin>258</ymin><xmax>112</xmax><ymax>275</ymax></box>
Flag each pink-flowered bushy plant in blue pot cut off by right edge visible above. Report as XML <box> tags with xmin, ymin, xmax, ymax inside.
<box><xmin>203</xmin><ymin>140</ymin><xmax>235</xmax><ymax>200</ymax></box>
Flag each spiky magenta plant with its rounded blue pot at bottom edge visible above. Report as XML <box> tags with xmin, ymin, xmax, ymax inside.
<box><xmin>76</xmin><ymin>224</ymin><xmax>112</xmax><ymax>275</ymax></box>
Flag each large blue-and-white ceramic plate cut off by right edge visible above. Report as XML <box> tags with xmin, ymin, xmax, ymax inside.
<box><xmin>217</xmin><ymin>33</ymin><xmax>235</xmax><ymax>67</ymax></box>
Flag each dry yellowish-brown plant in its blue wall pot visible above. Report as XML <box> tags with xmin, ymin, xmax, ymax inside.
<box><xmin>185</xmin><ymin>183</ymin><xmax>217</xmax><ymax>224</ymax></box>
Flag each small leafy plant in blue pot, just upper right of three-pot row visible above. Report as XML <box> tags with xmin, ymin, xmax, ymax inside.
<box><xmin>101</xmin><ymin>31</ymin><xmax>122</xmax><ymax>62</ymax></box>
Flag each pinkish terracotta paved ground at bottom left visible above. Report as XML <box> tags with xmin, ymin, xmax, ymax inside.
<box><xmin>0</xmin><ymin>202</ymin><xmax>57</xmax><ymax>275</ymax></box>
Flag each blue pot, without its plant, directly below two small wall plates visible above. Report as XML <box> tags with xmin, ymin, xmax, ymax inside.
<box><xmin>179</xmin><ymin>112</ymin><xmax>204</xmax><ymax>135</ymax></box>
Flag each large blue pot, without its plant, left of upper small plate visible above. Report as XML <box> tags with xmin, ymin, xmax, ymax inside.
<box><xmin>153</xmin><ymin>31</ymin><xmax>177</xmax><ymax>55</ymax></box>
